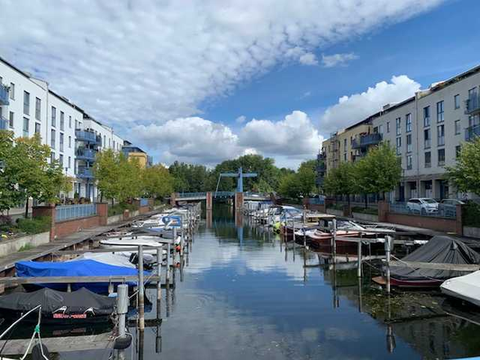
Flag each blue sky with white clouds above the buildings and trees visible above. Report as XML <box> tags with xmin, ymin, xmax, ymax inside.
<box><xmin>0</xmin><ymin>0</ymin><xmax>480</xmax><ymax>168</ymax></box>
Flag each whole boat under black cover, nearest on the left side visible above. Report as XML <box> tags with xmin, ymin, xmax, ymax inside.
<box><xmin>0</xmin><ymin>288</ymin><xmax>116</xmax><ymax>325</ymax></box>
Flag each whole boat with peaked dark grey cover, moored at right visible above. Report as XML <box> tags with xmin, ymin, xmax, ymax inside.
<box><xmin>372</xmin><ymin>235</ymin><xmax>480</xmax><ymax>288</ymax></box>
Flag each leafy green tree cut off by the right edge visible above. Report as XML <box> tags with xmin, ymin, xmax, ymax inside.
<box><xmin>446</xmin><ymin>137</ymin><xmax>480</xmax><ymax>196</ymax></box>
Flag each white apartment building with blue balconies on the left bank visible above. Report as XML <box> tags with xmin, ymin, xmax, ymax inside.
<box><xmin>0</xmin><ymin>58</ymin><xmax>123</xmax><ymax>200</ymax></box>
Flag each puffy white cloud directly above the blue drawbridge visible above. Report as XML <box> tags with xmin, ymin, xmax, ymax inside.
<box><xmin>240</xmin><ymin>111</ymin><xmax>323</xmax><ymax>157</ymax></box>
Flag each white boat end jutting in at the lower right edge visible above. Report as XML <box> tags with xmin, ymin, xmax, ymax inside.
<box><xmin>440</xmin><ymin>271</ymin><xmax>480</xmax><ymax>306</ymax></box>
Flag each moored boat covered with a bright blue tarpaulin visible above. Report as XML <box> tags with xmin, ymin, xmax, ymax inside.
<box><xmin>15</xmin><ymin>259</ymin><xmax>150</xmax><ymax>294</ymax></box>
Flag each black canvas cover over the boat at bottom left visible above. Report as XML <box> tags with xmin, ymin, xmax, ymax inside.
<box><xmin>0</xmin><ymin>288</ymin><xmax>116</xmax><ymax>316</ymax></box>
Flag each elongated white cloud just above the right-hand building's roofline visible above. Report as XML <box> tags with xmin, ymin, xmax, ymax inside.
<box><xmin>320</xmin><ymin>75</ymin><xmax>420</xmax><ymax>133</ymax></box>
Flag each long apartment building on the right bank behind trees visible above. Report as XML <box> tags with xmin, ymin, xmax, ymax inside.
<box><xmin>322</xmin><ymin>66</ymin><xmax>480</xmax><ymax>201</ymax></box>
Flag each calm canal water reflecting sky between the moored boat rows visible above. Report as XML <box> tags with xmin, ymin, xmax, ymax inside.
<box><xmin>64</xmin><ymin>207</ymin><xmax>480</xmax><ymax>360</ymax></box>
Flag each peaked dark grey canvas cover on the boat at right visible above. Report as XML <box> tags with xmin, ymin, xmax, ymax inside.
<box><xmin>391</xmin><ymin>235</ymin><xmax>480</xmax><ymax>280</ymax></box>
